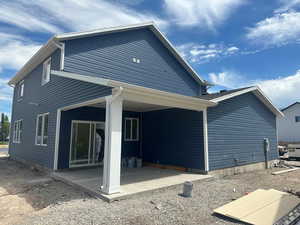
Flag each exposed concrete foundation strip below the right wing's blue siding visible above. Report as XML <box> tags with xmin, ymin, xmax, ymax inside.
<box><xmin>208</xmin><ymin>160</ymin><xmax>276</xmax><ymax>176</ymax></box>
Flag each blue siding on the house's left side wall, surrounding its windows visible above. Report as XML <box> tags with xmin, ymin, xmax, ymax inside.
<box><xmin>9</xmin><ymin>50</ymin><xmax>111</xmax><ymax>168</ymax></box>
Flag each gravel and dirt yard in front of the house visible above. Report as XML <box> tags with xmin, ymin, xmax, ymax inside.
<box><xmin>0</xmin><ymin>158</ymin><xmax>300</xmax><ymax>225</ymax></box>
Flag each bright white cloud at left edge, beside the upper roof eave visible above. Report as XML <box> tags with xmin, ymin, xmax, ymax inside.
<box><xmin>0</xmin><ymin>33</ymin><xmax>41</xmax><ymax>72</ymax></box>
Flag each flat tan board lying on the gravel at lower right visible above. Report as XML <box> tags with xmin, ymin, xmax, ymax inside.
<box><xmin>214</xmin><ymin>189</ymin><xmax>300</xmax><ymax>225</ymax></box>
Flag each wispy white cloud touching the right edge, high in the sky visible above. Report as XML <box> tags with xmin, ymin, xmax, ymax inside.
<box><xmin>246</xmin><ymin>12</ymin><xmax>300</xmax><ymax>46</ymax></box>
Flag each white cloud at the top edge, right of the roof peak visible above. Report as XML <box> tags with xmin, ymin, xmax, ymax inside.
<box><xmin>165</xmin><ymin>0</ymin><xmax>246</xmax><ymax>30</ymax></box>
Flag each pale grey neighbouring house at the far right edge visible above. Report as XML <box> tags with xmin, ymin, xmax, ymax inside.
<box><xmin>277</xmin><ymin>102</ymin><xmax>300</xmax><ymax>143</ymax></box>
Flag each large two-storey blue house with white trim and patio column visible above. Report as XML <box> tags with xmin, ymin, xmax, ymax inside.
<box><xmin>9</xmin><ymin>23</ymin><xmax>282</xmax><ymax>194</ymax></box>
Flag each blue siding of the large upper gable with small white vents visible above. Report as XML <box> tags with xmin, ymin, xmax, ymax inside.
<box><xmin>64</xmin><ymin>28</ymin><xmax>201</xmax><ymax>96</ymax></box>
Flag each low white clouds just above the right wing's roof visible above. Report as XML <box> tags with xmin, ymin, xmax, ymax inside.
<box><xmin>209</xmin><ymin>70</ymin><xmax>300</xmax><ymax>107</ymax></box>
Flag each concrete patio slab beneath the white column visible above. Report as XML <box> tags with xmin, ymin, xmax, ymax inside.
<box><xmin>52</xmin><ymin>167</ymin><xmax>212</xmax><ymax>202</ymax></box>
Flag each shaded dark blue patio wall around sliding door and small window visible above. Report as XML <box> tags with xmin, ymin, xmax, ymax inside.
<box><xmin>58</xmin><ymin>107</ymin><xmax>140</xmax><ymax>169</ymax></box>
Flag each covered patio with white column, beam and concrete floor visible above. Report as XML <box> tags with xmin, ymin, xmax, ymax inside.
<box><xmin>54</xmin><ymin>85</ymin><xmax>215</xmax><ymax>200</ymax></box>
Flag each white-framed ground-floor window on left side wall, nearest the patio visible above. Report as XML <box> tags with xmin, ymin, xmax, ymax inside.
<box><xmin>35</xmin><ymin>113</ymin><xmax>49</xmax><ymax>146</ymax></box>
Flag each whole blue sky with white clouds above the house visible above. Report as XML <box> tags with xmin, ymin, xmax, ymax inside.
<box><xmin>0</xmin><ymin>0</ymin><xmax>300</xmax><ymax>119</ymax></box>
